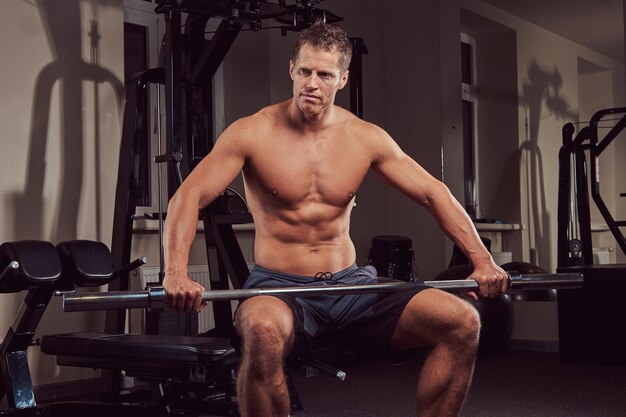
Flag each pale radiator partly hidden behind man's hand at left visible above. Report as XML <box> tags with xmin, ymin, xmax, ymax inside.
<box><xmin>138</xmin><ymin>262</ymin><xmax>254</xmax><ymax>333</ymax></box>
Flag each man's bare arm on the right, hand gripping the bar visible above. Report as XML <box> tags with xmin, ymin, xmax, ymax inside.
<box><xmin>373</xmin><ymin>128</ymin><xmax>509</xmax><ymax>297</ymax></box>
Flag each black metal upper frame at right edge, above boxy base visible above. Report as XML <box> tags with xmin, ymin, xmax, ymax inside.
<box><xmin>557</xmin><ymin>107</ymin><xmax>626</xmax><ymax>267</ymax></box>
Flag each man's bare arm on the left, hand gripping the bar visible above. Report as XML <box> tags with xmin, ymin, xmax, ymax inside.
<box><xmin>163</xmin><ymin>119</ymin><xmax>252</xmax><ymax>312</ymax></box>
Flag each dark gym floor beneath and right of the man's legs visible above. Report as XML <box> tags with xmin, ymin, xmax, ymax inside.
<box><xmin>292</xmin><ymin>351</ymin><xmax>626</xmax><ymax>417</ymax></box>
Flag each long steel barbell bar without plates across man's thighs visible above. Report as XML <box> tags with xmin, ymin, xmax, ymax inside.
<box><xmin>63</xmin><ymin>272</ymin><xmax>583</xmax><ymax>312</ymax></box>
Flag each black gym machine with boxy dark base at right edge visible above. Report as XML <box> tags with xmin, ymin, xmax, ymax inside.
<box><xmin>557</xmin><ymin>107</ymin><xmax>626</xmax><ymax>365</ymax></box>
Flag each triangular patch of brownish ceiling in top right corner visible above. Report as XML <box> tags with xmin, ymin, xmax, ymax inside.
<box><xmin>484</xmin><ymin>0</ymin><xmax>626</xmax><ymax>62</ymax></box>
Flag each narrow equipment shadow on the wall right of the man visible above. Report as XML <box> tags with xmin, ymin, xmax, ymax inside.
<box><xmin>519</xmin><ymin>60</ymin><xmax>578</xmax><ymax>266</ymax></box>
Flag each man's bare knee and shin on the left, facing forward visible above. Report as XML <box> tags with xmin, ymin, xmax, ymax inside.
<box><xmin>235</xmin><ymin>296</ymin><xmax>294</xmax><ymax>417</ymax></box>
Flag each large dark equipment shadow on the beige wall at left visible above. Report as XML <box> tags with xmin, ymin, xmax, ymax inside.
<box><xmin>13</xmin><ymin>0</ymin><xmax>124</xmax><ymax>242</ymax></box>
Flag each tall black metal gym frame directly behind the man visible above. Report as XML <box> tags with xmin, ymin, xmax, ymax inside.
<box><xmin>103</xmin><ymin>0</ymin><xmax>367</xmax><ymax>392</ymax></box>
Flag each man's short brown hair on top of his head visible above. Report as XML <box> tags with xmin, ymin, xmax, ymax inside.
<box><xmin>291</xmin><ymin>21</ymin><xmax>352</xmax><ymax>73</ymax></box>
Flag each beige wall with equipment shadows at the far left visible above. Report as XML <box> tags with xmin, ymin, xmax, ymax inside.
<box><xmin>0</xmin><ymin>0</ymin><xmax>123</xmax><ymax>384</ymax></box>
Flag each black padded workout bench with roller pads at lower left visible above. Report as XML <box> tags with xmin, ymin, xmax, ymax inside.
<box><xmin>0</xmin><ymin>240</ymin><xmax>239</xmax><ymax>417</ymax></box>
